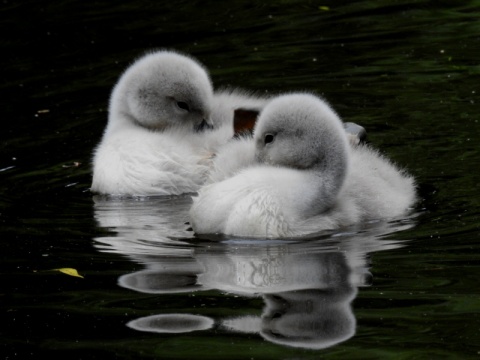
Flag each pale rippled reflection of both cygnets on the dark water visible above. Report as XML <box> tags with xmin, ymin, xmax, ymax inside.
<box><xmin>95</xmin><ymin>196</ymin><xmax>409</xmax><ymax>349</ymax></box>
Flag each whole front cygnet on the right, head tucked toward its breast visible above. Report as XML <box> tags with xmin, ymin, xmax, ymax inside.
<box><xmin>190</xmin><ymin>93</ymin><xmax>415</xmax><ymax>238</ymax></box>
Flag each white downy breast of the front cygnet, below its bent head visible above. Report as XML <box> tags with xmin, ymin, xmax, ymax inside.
<box><xmin>190</xmin><ymin>166</ymin><xmax>324</xmax><ymax>238</ymax></box>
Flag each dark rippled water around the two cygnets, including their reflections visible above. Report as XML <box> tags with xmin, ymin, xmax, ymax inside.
<box><xmin>0</xmin><ymin>0</ymin><xmax>480</xmax><ymax>359</ymax></box>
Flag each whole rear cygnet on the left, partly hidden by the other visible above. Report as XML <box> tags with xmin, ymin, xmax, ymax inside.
<box><xmin>91</xmin><ymin>50</ymin><xmax>266</xmax><ymax>195</ymax></box>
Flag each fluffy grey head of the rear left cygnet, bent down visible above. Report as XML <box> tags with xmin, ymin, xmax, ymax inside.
<box><xmin>110</xmin><ymin>51</ymin><xmax>213</xmax><ymax>131</ymax></box>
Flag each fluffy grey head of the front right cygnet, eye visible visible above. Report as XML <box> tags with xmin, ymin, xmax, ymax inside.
<box><xmin>254</xmin><ymin>93</ymin><xmax>348</xmax><ymax>183</ymax></box>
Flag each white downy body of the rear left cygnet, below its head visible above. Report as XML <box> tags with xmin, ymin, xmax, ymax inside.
<box><xmin>92</xmin><ymin>127</ymin><xmax>232</xmax><ymax>196</ymax></box>
